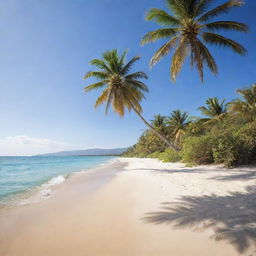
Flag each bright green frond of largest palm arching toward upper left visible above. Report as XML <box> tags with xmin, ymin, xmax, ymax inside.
<box><xmin>145</xmin><ymin>8</ymin><xmax>180</xmax><ymax>26</ymax></box>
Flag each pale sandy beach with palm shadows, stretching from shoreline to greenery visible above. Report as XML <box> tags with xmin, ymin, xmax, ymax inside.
<box><xmin>0</xmin><ymin>158</ymin><xmax>256</xmax><ymax>256</ymax></box>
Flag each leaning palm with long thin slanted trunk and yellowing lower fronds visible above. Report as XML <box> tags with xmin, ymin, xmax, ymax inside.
<box><xmin>84</xmin><ymin>50</ymin><xmax>178</xmax><ymax>150</ymax></box>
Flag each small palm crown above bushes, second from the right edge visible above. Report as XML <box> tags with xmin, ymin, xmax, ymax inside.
<box><xmin>198</xmin><ymin>97</ymin><xmax>229</xmax><ymax>121</ymax></box>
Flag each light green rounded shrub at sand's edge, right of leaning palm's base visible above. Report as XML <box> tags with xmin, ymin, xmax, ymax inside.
<box><xmin>181</xmin><ymin>135</ymin><xmax>213</xmax><ymax>164</ymax></box>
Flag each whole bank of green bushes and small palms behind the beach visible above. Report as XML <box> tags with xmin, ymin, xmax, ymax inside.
<box><xmin>124</xmin><ymin>84</ymin><xmax>256</xmax><ymax>167</ymax></box>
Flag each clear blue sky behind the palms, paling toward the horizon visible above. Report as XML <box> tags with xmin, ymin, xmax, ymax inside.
<box><xmin>0</xmin><ymin>0</ymin><xmax>256</xmax><ymax>155</ymax></box>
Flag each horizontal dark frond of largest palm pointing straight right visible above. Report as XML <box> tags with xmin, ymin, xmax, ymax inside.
<box><xmin>204</xmin><ymin>21</ymin><xmax>249</xmax><ymax>32</ymax></box>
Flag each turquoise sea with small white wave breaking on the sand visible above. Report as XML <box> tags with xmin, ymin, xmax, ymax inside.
<box><xmin>0</xmin><ymin>156</ymin><xmax>113</xmax><ymax>203</ymax></box>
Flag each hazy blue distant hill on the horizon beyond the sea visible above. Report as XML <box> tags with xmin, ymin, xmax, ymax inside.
<box><xmin>36</xmin><ymin>148</ymin><xmax>127</xmax><ymax>156</ymax></box>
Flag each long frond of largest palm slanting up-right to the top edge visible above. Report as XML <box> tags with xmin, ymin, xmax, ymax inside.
<box><xmin>198</xmin><ymin>0</ymin><xmax>244</xmax><ymax>21</ymax></box>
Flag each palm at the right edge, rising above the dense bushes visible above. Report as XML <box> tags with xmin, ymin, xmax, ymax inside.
<box><xmin>230</xmin><ymin>83</ymin><xmax>256</xmax><ymax>122</ymax></box>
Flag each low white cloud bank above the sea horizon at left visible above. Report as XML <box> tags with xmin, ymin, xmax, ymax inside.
<box><xmin>0</xmin><ymin>135</ymin><xmax>69</xmax><ymax>156</ymax></box>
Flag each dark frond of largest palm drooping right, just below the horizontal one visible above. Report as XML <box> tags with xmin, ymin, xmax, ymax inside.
<box><xmin>202</xmin><ymin>32</ymin><xmax>246</xmax><ymax>55</ymax></box>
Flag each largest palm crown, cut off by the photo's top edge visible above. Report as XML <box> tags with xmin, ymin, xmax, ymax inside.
<box><xmin>141</xmin><ymin>0</ymin><xmax>248</xmax><ymax>81</ymax></box>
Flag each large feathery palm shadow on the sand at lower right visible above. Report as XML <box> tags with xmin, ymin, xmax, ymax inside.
<box><xmin>143</xmin><ymin>186</ymin><xmax>256</xmax><ymax>253</ymax></box>
